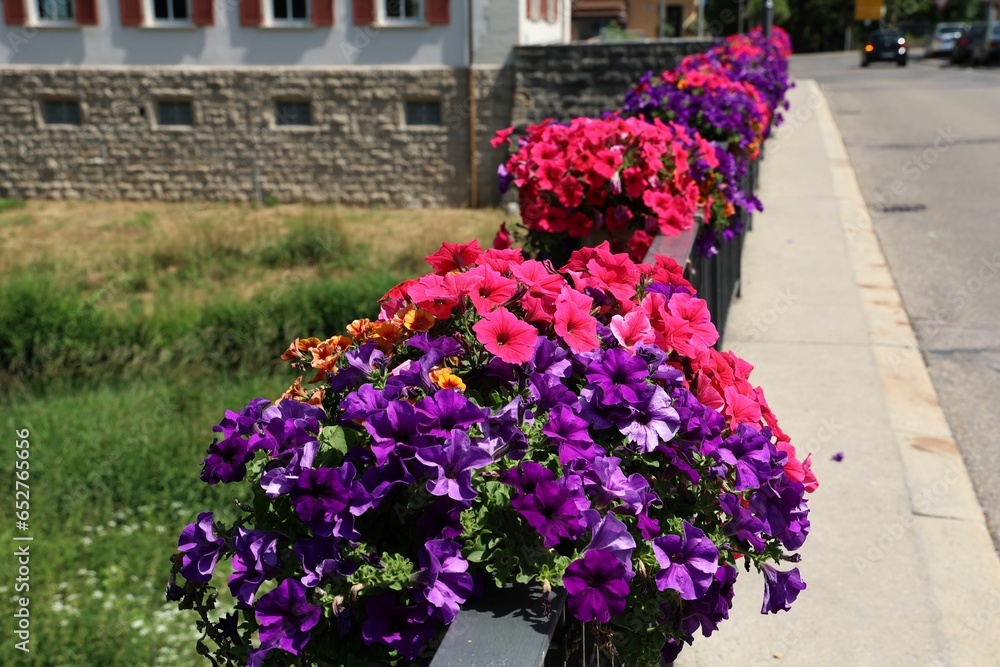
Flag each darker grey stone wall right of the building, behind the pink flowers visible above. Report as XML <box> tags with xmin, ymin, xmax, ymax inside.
<box><xmin>513</xmin><ymin>38</ymin><xmax>713</xmax><ymax>126</ymax></box>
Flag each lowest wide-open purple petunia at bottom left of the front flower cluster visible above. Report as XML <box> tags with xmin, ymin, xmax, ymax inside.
<box><xmin>255</xmin><ymin>579</ymin><xmax>323</xmax><ymax>655</ymax></box>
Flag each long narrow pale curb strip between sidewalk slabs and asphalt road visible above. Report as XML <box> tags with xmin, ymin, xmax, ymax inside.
<box><xmin>797</xmin><ymin>79</ymin><xmax>1000</xmax><ymax>666</ymax></box>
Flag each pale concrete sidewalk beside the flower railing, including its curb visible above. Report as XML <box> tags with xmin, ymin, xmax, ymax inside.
<box><xmin>675</xmin><ymin>80</ymin><xmax>1000</xmax><ymax>667</ymax></box>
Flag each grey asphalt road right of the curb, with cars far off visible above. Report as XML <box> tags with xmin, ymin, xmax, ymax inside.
<box><xmin>792</xmin><ymin>53</ymin><xmax>1000</xmax><ymax>552</ymax></box>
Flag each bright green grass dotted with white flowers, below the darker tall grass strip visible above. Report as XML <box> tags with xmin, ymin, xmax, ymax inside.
<box><xmin>0</xmin><ymin>374</ymin><xmax>288</xmax><ymax>667</ymax></box>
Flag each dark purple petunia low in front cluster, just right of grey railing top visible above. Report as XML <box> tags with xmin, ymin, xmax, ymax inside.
<box><xmin>563</xmin><ymin>549</ymin><xmax>628</xmax><ymax>623</ymax></box>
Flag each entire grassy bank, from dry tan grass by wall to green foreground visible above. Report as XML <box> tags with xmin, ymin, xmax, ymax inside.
<box><xmin>0</xmin><ymin>202</ymin><xmax>502</xmax><ymax>667</ymax></box>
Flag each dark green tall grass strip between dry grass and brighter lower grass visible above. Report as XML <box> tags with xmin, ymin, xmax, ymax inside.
<box><xmin>0</xmin><ymin>272</ymin><xmax>399</xmax><ymax>391</ymax></box>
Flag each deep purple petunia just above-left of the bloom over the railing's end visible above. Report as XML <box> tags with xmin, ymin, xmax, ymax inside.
<box><xmin>511</xmin><ymin>477</ymin><xmax>590</xmax><ymax>547</ymax></box>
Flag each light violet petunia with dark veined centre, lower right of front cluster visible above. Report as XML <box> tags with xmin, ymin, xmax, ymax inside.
<box><xmin>653</xmin><ymin>521</ymin><xmax>719</xmax><ymax>600</ymax></box>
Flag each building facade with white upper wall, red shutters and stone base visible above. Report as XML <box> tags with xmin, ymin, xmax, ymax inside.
<box><xmin>0</xmin><ymin>0</ymin><xmax>571</xmax><ymax>207</ymax></box>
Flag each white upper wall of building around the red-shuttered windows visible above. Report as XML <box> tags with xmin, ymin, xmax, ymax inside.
<box><xmin>0</xmin><ymin>0</ymin><xmax>468</xmax><ymax>66</ymax></box>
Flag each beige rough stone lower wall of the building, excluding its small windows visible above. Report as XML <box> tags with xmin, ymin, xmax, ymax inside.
<box><xmin>0</xmin><ymin>67</ymin><xmax>513</xmax><ymax>207</ymax></box>
